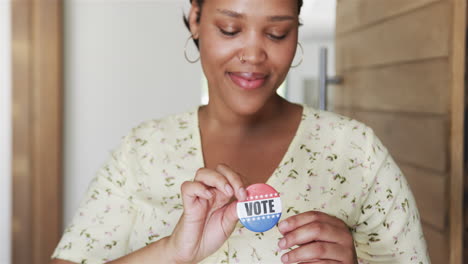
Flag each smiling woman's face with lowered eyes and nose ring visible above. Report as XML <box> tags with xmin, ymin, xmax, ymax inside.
<box><xmin>189</xmin><ymin>0</ymin><xmax>299</xmax><ymax>114</ymax></box>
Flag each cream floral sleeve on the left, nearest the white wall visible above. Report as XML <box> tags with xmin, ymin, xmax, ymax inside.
<box><xmin>52</xmin><ymin>135</ymin><xmax>136</xmax><ymax>264</ymax></box>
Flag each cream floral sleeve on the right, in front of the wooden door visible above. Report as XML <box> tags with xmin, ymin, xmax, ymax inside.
<box><xmin>353</xmin><ymin>131</ymin><xmax>430</xmax><ymax>264</ymax></box>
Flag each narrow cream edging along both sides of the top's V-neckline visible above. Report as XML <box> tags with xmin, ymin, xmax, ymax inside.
<box><xmin>193</xmin><ymin>105</ymin><xmax>308</xmax><ymax>186</ymax></box>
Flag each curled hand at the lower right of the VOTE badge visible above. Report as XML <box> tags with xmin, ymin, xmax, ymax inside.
<box><xmin>278</xmin><ymin>211</ymin><xmax>358</xmax><ymax>264</ymax></box>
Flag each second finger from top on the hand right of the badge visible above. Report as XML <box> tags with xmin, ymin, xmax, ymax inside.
<box><xmin>278</xmin><ymin>222</ymin><xmax>353</xmax><ymax>249</ymax></box>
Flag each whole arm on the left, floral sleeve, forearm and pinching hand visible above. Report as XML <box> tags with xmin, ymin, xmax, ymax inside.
<box><xmin>52</xmin><ymin>117</ymin><xmax>245</xmax><ymax>263</ymax></box>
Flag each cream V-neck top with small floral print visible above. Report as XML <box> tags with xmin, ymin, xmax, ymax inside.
<box><xmin>52</xmin><ymin>106</ymin><xmax>430</xmax><ymax>264</ymax></box>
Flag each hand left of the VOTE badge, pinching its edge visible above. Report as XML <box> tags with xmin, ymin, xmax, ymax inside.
<box><xmin>167</xmin><ymin>165</ymin><xmax>247</xmax><ymax>263</ymax></box>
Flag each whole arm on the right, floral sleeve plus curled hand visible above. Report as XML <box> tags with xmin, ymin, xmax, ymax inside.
<box><xmin>278</xmin><ymin>129</ymin><xmax>430</xmax><ymax>264</ymax></box>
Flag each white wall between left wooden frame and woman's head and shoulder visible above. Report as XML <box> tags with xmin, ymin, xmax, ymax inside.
<box><xmin>64</xmin><ymin>0</ymin><xmax>201</xmax><ymax>224</ymax></box>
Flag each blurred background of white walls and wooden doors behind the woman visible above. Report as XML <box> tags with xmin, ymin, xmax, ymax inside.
<box><xmin>0</xmin><ymin>0</ymin><xmax>466</xmax><ymax>264</ymax></box>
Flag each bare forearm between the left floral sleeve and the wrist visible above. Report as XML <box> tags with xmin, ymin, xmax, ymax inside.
<box><xmin>108</xmin><ymin>237</ymin><xmax>176</xmax><ymax>264</ymax></box>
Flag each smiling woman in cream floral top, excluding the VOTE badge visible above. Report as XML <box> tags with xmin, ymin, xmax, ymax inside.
<box><xmin>53</xmin><ymin>0</ymin><xmax>429</xmax><ymax>264</ymax></box>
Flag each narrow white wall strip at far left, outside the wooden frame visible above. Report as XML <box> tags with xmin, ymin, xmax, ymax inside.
<box><xmin>0</xmin><ymin>1</ymin><xmax>11</xmax><ymax>264</ymax></box>
